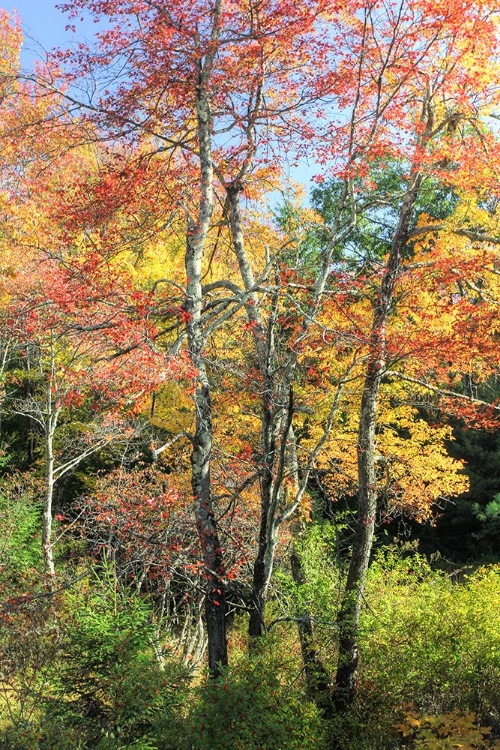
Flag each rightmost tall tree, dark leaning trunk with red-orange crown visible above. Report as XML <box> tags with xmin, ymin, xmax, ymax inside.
<box><xmin>300</xmin><ymin>3</ymin><xmax>495</xmax><ymax>705</ymax></box>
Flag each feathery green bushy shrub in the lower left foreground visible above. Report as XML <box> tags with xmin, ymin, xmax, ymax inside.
<box><xmin>29</xmin><ymin>579</ymin><xmax>189</xmax><ymax>750</ymax></box>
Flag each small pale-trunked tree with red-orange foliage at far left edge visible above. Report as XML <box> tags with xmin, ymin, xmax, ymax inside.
<box><xmin>0</xmin><ymin>79</ymin><xmax>182</xmax><ymax>576</ymax></box>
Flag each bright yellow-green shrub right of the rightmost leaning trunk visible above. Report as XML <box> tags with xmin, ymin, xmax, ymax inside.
<box><xmin>361</xmin><ymin>553</ymin><xmax>500</xmax><ymax>714</ymax></box>
